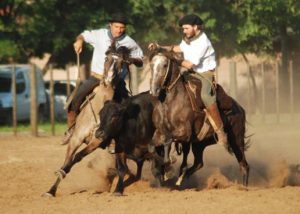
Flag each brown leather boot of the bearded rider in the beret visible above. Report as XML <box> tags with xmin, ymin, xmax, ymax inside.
<box><xmin>206</xmin><ymin>103</ymin><xmax>228</xmax><ymax>146</ymax></box>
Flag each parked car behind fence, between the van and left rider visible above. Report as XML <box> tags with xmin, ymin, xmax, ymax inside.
<box><xmin>45</xmin><ymin>80</ymin><xmax>76</xmax><ymax>121</ymax></box>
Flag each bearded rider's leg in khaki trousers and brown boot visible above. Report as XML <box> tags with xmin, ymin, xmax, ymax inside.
<box><xmin>201</xmin><ymin>72</ymin><xmax>227</xmax><ymax>145</ymax></box>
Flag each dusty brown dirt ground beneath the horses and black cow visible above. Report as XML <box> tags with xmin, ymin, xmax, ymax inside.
<box><xmin>0</xmin><ymin>119</ymin><xmax>300</xmax><ymax>214</ymax></box>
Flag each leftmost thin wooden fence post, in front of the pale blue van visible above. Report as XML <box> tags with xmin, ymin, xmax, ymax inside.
<box><xmin>12</xmin><ymin>63</ymin><xmax>17</xmax><ymax>136</ymax></box>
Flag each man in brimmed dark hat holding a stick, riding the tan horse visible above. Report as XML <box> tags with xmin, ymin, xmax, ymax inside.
<box><xmin>64</xmin><ymin>13</ymin><xmax>143</xmax><ymax>142</ymax></box>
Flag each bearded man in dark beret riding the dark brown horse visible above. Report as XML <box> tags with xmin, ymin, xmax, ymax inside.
<box><xmin>148</xmin><ymin>14</ymin><xmax>227</xmax><ymax>145</ymax></box>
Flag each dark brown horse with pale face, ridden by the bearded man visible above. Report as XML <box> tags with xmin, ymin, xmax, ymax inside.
<box><xmin>150</xmin><ymin>49</ymin><xmax>249</xmax><ymax>185</ymax></box>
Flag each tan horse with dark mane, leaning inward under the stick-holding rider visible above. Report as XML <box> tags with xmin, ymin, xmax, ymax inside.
<box><xmin>44</xmin><ymin>43</ymin><xmax>129</xmax><ymax>196</ymax></box>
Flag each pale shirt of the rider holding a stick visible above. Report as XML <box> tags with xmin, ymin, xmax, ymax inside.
<box><xmin>81</xmin><ymin>28</ymin><xmax>143</xmax><ymax>74</ymax></box>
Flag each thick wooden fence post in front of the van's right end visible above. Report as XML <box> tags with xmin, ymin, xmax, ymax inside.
<box><xmin>30</xmin><ymin>64</ymin><xmax>38</xmax><ymax>136</ymax></box>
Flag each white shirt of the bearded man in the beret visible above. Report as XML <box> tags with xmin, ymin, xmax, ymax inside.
<box><xmin>179</xmin><ymin>32</ymin><xmax>217</xmax><ymax>73</ymax></box>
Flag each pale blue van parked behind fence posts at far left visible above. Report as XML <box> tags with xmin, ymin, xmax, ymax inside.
<box><xmin>0</xmin><ymin>64</ymin><xmax>46</xmax><ymax>124</ymax></box>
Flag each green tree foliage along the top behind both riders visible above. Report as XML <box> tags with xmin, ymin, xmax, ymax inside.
<box><xmin>0</xmin><ymin>0</ymin><xmax>300</xmax><ymax>72</ymax></box>
